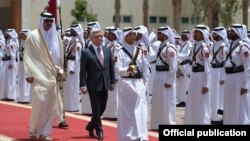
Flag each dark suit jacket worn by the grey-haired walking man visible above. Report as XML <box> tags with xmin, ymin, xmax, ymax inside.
<box><xmin>80</xmin><ymin>45</ymin><xmax>115</xmax><ymax>92</ymax></box>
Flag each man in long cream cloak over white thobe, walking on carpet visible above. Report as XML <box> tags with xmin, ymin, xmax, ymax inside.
<box><xmin>23</xmin><ymin>12</ymin><xmax>64</xmax><ymax>141</ymax></box>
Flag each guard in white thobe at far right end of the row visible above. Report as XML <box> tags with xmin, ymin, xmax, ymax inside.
<box><xmin>223</xmin><ymin>24</ymin><xmax>250</xmax><ymax>125</ymax></box>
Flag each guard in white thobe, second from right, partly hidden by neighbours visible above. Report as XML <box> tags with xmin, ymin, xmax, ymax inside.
<box><xmin>211</xmin><ymin>27</ymin><xmax>229</xmax><ymax>124</ymax></box>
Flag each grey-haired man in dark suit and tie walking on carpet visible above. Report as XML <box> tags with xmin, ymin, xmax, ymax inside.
<box><xmin>80</xmin><ymin>28</ymin><xmax>115</xmax><ymax>140</ymax></box>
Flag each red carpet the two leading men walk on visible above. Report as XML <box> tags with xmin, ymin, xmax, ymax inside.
<box><xmin>0</xmin><ymin>102</ymin><xmax>158</xmax><ymax>141</ymax></box>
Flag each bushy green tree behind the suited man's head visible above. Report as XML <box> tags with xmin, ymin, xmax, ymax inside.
<box><xmin>71</xmin><ymin>0</ymin><xmax>97</xmax><ymax>23</ymax></box>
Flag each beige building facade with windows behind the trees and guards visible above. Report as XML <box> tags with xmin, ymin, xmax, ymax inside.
<box><xmin>0</xmin><ymin>0</ymin><xmax>249</xmax><ymax>30</ymax></box>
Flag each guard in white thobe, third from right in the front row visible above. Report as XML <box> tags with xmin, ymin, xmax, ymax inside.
<box><xmin>184</xmin><ymin>25</ymin><xmax>211</xmax><ymax>125</ymax></box>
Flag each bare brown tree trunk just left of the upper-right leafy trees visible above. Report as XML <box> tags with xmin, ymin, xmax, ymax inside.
<box><xmin>172</xmin><ymin>0</ymin><xmax>181</xmax><ymax>32</ymax></box>
